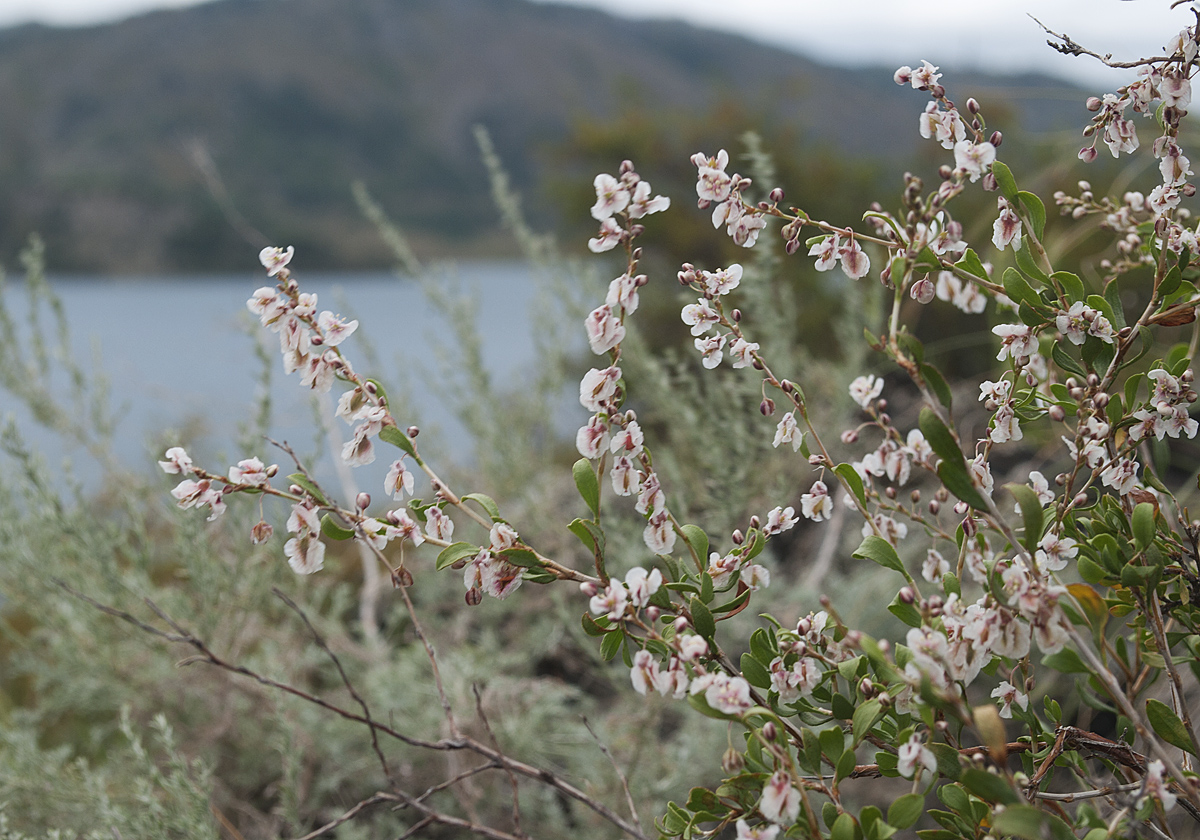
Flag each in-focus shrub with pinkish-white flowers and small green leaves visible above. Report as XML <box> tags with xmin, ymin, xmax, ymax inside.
<box><xmin>152</xmin><ymin>16</ymin><xmax>1200</xmax><ymax>840</ymax></box>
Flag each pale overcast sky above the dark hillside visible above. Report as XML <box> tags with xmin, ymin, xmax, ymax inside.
<box><xmin>0</xmin><ymin>0</ymin><xmax>1194</xmax><ymax>88</ymax></box>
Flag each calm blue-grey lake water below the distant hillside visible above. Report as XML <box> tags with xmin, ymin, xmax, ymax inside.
<box><xmin>0</xmin><ymin>262</ymin><xmax>576</xmax><ymax>492</ymax></box>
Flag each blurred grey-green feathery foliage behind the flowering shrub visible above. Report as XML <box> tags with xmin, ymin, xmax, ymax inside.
<box><xmin>0</xmin><ymin>131</ymin><xmax>874</xmax><ymax>839</ymax></box>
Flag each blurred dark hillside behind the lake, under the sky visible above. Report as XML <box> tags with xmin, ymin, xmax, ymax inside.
<box><xmin>0</xmin><ymin>0</ymin><xmax>1084</xmax><ymax>272</ymax></box>
